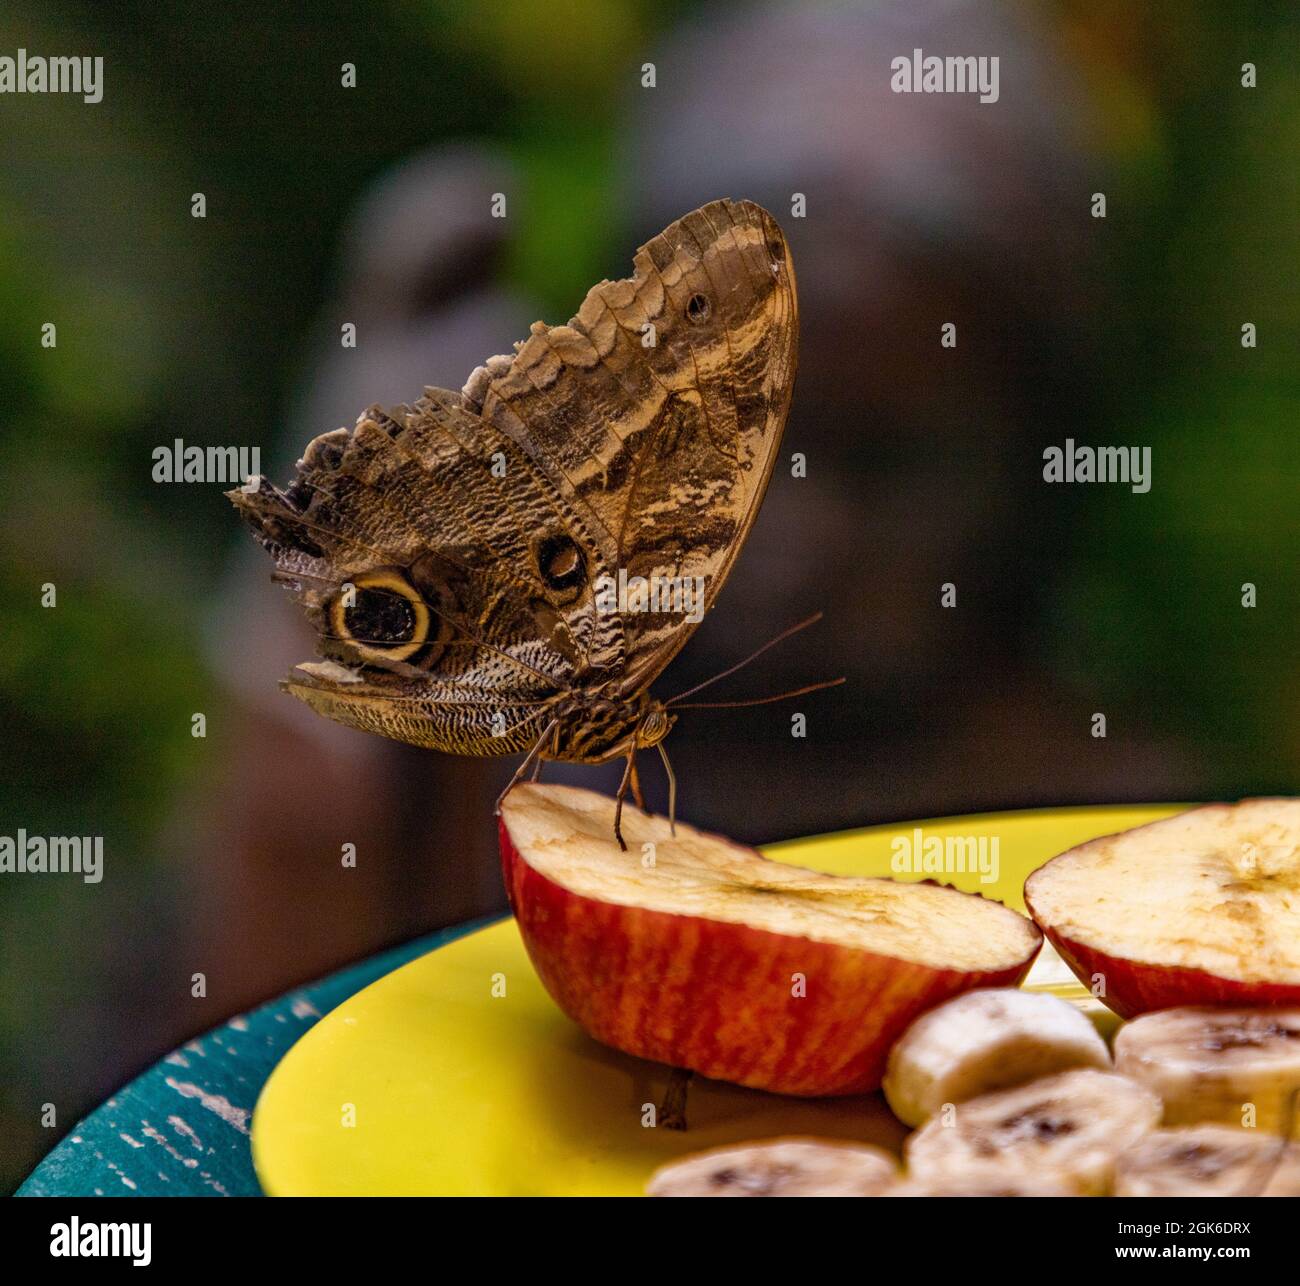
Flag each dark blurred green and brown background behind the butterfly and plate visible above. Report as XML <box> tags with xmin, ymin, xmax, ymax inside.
<box><xmin>0</xmin><ymin>0</ymin><xmax>1300</xmax><ymax>1187</ymax></box>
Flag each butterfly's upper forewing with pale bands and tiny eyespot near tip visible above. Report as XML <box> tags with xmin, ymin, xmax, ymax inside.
<box><xmin>462</xmin><ymin>200</ymin><xmax>798</xmax><ymax>694</ymax></box>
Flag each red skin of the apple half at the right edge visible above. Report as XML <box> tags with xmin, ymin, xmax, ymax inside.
<box><xmin>1026</xmin><ymin>920</ymin><xmax>1300</xmax><ymax>1018</ymax></box>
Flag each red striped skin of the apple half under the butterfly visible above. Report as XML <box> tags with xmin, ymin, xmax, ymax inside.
<box><xmin>499</xmin><ymin>822</ymin><xmax>1041</xmax><ymax>1097</ymax></box>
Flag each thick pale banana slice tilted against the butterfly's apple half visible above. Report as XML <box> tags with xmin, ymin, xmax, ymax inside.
<box><xmin>884</xmin><ymin>987</ymin><xmax>1110</xmax><ymax>1126</ymax></box>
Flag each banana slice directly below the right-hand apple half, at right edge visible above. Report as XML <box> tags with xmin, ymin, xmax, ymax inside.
<box><xmin>1115</xmin><ymin>1009</ymin><xmax>1300</xmax><ymax>1134</ymax></box>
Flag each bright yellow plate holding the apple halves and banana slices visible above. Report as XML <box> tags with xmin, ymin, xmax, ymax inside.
<box><xmin>252</xmin><ymin>805</ymin><xmax>1186</xmax><ymax>1196</ymax></box>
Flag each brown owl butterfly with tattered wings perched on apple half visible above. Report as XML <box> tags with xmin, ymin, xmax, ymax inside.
<box><xmin>229</xmin><ymin>200</ymin><xmax>798</xmax><ymax>843</ymax></box>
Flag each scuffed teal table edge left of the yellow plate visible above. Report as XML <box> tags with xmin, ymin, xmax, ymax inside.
<box><xmin>14</xmin><ymin>915</ymin><xmax>501</xmax><ymax>1196</ymax></box>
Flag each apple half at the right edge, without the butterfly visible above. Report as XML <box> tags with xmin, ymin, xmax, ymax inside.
<box><xmin>1024</xmin><ymin>800</ymin><xmax>1300</xmax><ymax>1018</ymax></box>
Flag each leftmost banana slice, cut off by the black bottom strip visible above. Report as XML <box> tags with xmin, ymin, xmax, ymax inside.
<box><xmin>646</xmin><ymin>1138</ymin><xmax>898</xmax><ymax>1196</ymax></box>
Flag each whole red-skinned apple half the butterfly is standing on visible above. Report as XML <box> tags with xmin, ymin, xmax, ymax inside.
<box><xmin>501</xmin><ymin>785</ymin><xmax>1043</xmax><ymax>1096</ymax></box>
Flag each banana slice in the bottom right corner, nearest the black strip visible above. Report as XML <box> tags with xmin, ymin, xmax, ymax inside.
<box><xmin>1115</xmin><ymin>1125</ymin><xmax>1300</xmax><ymax>1196</ymax></box>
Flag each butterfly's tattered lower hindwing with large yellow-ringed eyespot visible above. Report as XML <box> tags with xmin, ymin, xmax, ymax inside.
<box><xmin>229</xmin><ymin>389</ymin><xmax>624</xmax><ymax>754</ymax></box>
